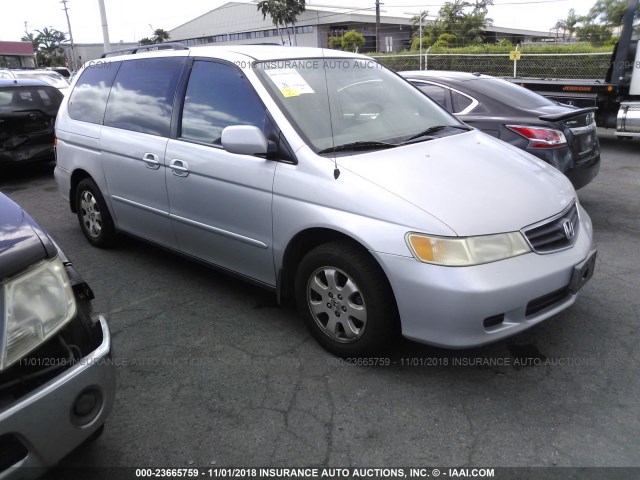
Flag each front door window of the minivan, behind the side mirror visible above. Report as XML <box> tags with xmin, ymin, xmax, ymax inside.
<box><xmin>180</xmin><ymin>61</ymin><xmax>266</xmax><ymax>145</ymax></box>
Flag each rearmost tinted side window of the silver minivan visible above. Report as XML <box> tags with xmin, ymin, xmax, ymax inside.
<box><xmin>69</xmin><ymin>62</ymin><xmax>122</xmax><ymax>124</ymax></box>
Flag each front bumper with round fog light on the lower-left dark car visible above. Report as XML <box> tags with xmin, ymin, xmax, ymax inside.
<box><xmin>0</xmin><ymin>316</ymin><xmax>115</xmax><ymax>480</ymax></box>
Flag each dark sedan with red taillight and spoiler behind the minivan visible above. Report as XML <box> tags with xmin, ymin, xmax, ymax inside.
<box><xmin>400</xmin><ymin>70</ymin><xmax>600</xmax><ymax>189</ymax></box>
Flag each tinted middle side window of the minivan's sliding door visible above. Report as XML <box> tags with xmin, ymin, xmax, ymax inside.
<box><xmin>104</xmin><ymin>57</ymin><xmax>185</xmax><ymax>137</ymax></box>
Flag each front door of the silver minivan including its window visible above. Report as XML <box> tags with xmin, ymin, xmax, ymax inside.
<box><xmin>166</xmin><ymin>60</ymin><xmax>277</xmax><ymax>285</ymax></box>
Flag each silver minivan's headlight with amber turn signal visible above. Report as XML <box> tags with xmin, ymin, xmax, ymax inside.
<box><xmin>407</xmin><ymin>232</ymin><xmax>531</xmax><ymax>267</ymax></box>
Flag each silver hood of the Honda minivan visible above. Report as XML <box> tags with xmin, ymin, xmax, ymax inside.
<box><xmin>339</xmin><ymin>131</ymin><xmax>575</xmax><ymax>236</ymax></box>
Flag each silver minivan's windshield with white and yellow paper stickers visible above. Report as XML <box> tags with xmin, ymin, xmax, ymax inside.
<box><xmin>256</xmin><ymin>58</ymin><xmax>463</xmax><ymax>152</ymax></box>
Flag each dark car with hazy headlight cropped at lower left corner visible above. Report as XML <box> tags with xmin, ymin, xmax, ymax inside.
<box><xmin>0</xmin><ymin>193</ymin><xmax>115</xmax><ymax>479</ymax></box>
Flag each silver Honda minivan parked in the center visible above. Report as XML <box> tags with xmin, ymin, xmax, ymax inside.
<box><xmin>55</xmin><ymin>46</ymin><xmax>595</xmax><ymax>356</ymax></box>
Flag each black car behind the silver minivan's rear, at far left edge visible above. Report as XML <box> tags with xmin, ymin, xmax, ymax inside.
<box><xmin>0</xmin><ymin>79</ymin><xmax>63</xmax><ymax>166</ymax></box>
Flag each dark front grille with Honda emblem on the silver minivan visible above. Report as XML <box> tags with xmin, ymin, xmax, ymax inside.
<box><xmin>524</xmin><ymin>203</ymin><xmax>580</xmax><ymax>253</ymax></box>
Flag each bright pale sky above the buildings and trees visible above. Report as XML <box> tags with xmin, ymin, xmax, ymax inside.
<box><xmin>0</xmin><ymin>0</ymin><xmax>595</xmax><ymax>43</ymax></box>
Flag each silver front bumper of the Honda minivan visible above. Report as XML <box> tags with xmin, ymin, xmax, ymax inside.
<box><xmin>372</xmin><ymin>207</ymin><xmax>593</xmax><ymax>348</ymax></box>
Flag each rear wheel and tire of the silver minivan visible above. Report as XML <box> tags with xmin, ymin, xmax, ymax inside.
<box><xmin>75</xmin><ymin>178</ymin><xmax>116</xmax><ymax>248</ymax></box>
